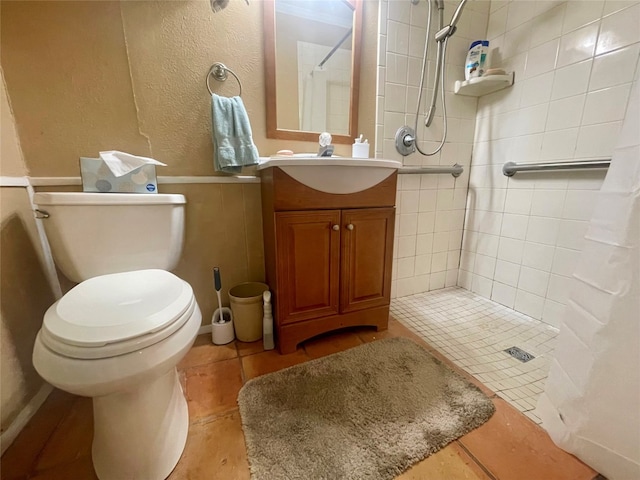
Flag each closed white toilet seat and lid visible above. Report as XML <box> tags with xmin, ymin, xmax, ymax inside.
<box><xmin>41</xmin><ymin>270</ymin><xmax>196</xmax><ymax>359</ymax></box>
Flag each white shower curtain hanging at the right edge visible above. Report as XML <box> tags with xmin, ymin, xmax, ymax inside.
<box><xmin>537</xmin><ymin>79</ymin><xmax>640</xmax><ymax>480</ymax></box>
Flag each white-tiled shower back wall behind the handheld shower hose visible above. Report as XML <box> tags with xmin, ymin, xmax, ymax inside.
<box><xmin>376</xmin><ymin>0</ymin><xmax>489</xmax><ymax>297</ymax></box>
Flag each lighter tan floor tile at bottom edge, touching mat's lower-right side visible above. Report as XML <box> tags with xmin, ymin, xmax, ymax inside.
<box><xmin>396</xmin><ymin>442</ymin><xmax>492</xmax><ymax>480</ymax></box>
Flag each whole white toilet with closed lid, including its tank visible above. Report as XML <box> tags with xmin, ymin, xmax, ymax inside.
<box><xmin>33</xmin><ymin>192</ymin><xmax>202</xmax><ymax>480</ymax></box>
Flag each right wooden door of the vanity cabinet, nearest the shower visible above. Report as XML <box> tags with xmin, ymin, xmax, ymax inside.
<box><xmin>340</xmin><ymin>208</ymin><xmax>395</xmax><ymax>313</ymax></box>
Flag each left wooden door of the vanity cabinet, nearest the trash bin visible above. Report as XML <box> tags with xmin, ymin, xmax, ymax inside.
<box><xmin>275</xmin><ymin>210</ymin><xmax>340</xmax><ymax>325</ymax></box>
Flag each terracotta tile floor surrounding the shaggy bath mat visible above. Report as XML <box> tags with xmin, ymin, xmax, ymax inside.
<box><xmin>0</xmin><ymin>319</ymin><xmax>597</xmax><ymax>480</ymax></box>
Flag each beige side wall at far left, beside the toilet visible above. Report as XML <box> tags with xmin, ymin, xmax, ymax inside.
<box><xmin>0</xmin><ymin>72</ymin><xmax>53</xmax><ymax>432</ymax></box>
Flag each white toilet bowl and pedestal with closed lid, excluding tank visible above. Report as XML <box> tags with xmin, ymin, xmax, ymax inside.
<box><xmin>33</xmin><ymin>269</ymin><xmax>202</xmax><ymax>480</ymax></box>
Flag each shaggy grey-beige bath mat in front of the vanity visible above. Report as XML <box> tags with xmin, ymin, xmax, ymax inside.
<box><xmin>238</xmin><ymin>338</ymin><xmax>495</xmax><ymax>480</ymax></box>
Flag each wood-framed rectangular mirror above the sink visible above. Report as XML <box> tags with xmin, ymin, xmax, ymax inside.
<box><xmin>264</xmin><ymin>0</ymin><xmax>362</xmax><ymax>144</ymax></box>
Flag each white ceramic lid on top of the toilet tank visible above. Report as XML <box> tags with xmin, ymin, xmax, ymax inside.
<box><xmin>33</xmin><ymin>192</ymin><xmax>187</xmax><ymax>205</ymax></box>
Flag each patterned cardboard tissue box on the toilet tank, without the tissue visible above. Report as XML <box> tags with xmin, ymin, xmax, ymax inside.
<box><xmin>80</xmin><ymin>157</ymin><xmax>158</xmax><ymax>193</ymax></box>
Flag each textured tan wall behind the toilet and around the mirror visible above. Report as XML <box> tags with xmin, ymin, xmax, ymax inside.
<box><xmin>0</xmin><ymin>0</ymin><xmax>377</xmax><ymax>324</ymax></box>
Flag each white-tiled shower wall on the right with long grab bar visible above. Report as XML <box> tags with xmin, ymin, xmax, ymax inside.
<box><xmin>458</xmin><ymin>0</ymin><xmax>640</xmax><ymax>325</ymax></box>
